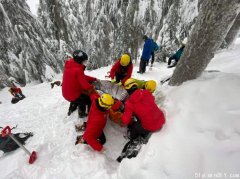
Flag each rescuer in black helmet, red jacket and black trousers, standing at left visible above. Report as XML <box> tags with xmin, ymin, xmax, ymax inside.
<box><xmin>62</xmin><ymin>50</ymin><xmax>97</xmax><ymax>117</ymax></box>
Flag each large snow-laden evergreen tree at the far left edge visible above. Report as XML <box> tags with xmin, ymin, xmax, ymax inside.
<box><xmin>0</xmin><ymin>0</ymin><xmax>62</xmax><ymax>85</ymax></box>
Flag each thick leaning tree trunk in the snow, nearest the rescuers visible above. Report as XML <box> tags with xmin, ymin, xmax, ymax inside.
<box><xmin>169</xmin><ymin>0</ymin><xmax>240</xmax><ymax>86</ymax></box>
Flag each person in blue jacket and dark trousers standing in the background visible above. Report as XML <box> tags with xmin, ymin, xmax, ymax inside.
<box><xmin>137</xmin><ymin>35</ymin><xmax>159</xmax><ymax>74</ymax></box>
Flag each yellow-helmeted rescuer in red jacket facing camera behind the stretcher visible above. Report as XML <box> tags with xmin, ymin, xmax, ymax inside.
<box><xmin>109</xmin><ymin>54</ymin><xmax>133</xmax><ymax>86</ymax></box>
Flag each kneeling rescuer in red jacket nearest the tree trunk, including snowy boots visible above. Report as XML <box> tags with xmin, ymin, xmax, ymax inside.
<box><xmin>117</xmin><ymin>82</ymin><xmax>165</xmax><ymax>162</ymax></box>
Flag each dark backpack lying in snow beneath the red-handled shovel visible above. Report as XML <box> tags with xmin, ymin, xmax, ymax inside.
<box><xmin>0</xmin><ymin>132</ymin><xmax>33</xmax><ymax>153</ymax></box>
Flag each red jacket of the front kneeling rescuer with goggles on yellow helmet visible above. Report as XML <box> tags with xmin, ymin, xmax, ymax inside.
<box><xmin>83</xmin><ymin>95</ymin><xmax>108</xmax><ymax>151</ymax></box>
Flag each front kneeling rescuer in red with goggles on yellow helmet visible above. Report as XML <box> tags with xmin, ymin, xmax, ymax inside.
<box><xmin>76</xmin><ymin>93</ymin><xmax>114</xmax><ymax>152</ymax></box>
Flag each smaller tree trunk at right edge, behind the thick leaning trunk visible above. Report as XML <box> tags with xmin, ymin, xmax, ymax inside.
<box><xmin>225</xmin><ymin>13</ymin><xmax>240</xmax><ymax>47</ymax></box>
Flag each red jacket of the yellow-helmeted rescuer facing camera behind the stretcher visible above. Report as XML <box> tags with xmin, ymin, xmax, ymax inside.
<box><xmin>110</xmin><ymin>59</ymin><xmax>133</xmax><ymax>84</ymax></box>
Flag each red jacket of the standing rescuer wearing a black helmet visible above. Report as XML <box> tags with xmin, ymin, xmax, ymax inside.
<box><xmin>62</xmin><ymin>58</ymin><xmax>96</xmax><ymax>102</ymax></box>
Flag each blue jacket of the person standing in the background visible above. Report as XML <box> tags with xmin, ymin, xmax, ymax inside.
<box><xmin>141</xmin><ymin>38</ymin><xmax>156</xmax><ymax>61</ymax></box>
